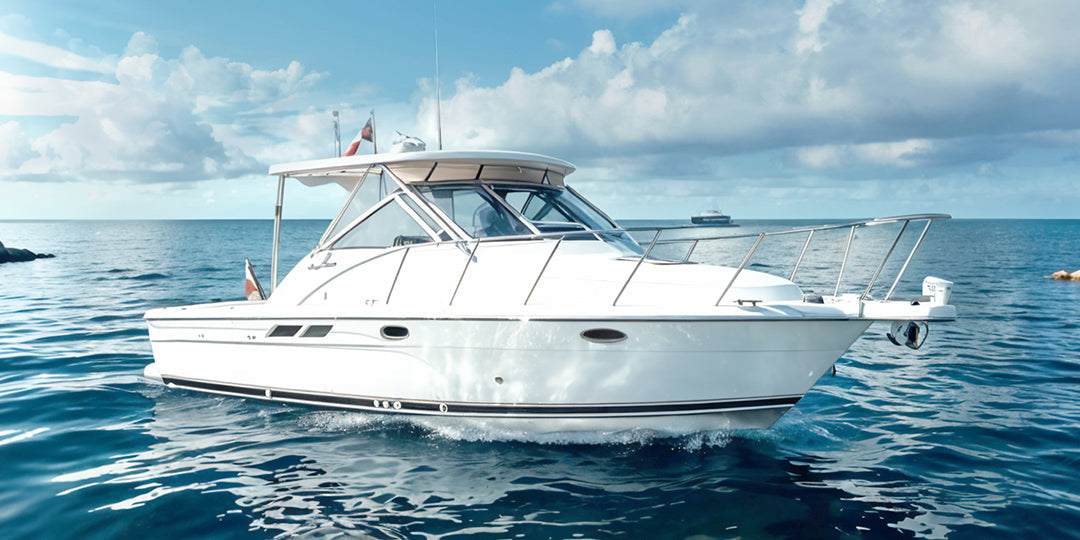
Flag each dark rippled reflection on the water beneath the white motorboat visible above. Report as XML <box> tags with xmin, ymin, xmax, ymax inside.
<box><xmin>44</xmin><ymin>388</ymin><xmax>985</xmax><ymax>538</ymax></box>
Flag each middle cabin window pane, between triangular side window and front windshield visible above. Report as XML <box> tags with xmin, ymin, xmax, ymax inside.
<box><xmin>421</xmin><ymin>186</ymin><xmax>532</xmax><ymax>238</ymax></box>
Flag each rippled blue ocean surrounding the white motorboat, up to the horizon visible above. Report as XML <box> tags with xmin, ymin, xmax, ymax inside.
<box><xmin>0</xmin><ymin>216</ymin><xmax>1080</xmax><ymax>539</ymax></box>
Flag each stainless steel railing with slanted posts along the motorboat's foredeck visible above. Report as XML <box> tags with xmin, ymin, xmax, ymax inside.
<box><xmin>300</xmin><ymin>214</ymin><xmax>951</xmax><ymax>306</ymax></box>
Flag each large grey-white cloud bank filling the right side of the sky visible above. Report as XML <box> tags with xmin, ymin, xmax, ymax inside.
<box><xmin>427</xmin><ymin>0</ymin><xmax>1080</xmax><ymax>179</ymax></box>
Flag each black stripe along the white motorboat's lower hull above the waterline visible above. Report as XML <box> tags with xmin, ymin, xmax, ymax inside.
<box><xmin>164</xmin><ymin>377</ymin><xmax>800</xmax><ymax>417</ymax></box>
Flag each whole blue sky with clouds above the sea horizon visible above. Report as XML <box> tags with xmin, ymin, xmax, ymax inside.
<box><xmin>0</xmin><ymin>0</ymin><xmax>1080</xmax><ymax>220</ymax></box>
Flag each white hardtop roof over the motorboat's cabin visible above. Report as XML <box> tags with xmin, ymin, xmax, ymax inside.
<box><xmin>270</xmin><ymin>150</ymin><xmax>573</xmax><ymax>188</ymax></box>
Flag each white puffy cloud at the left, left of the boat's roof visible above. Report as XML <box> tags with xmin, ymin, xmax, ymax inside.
<box><xmin>0</xmin><ymin>32</ymin><xmax>320</xmax><ymax>183</ymax></box>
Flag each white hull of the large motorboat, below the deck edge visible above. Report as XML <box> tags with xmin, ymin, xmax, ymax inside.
<box><xmin>148</xmin><ymin>318</ymin><xmax>870</xmax><ymax>433</ymax></box>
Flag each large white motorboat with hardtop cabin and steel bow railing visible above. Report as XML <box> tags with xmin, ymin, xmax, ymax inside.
<box><xmin>145</xmin><ymin>151</ymin><xmax>956</xmax><ymax>433</ymax></box>
